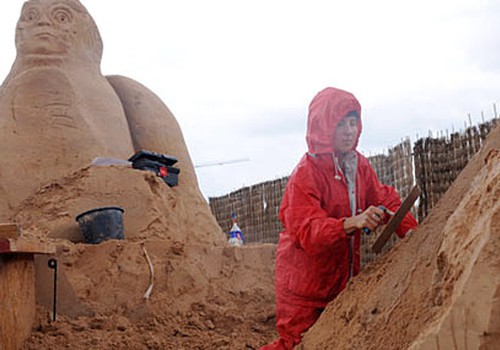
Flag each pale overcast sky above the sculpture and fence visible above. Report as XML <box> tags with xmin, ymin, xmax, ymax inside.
<box><xmin>0</xmin><ymin>0</ymin><xmax>500</xmax><ymax>197</ymax></box>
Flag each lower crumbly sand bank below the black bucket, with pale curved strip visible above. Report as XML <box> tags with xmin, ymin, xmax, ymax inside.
<box><xmin>24</xmin><ymin>240</ymin><xmax>275</xmax><ymax>349</ymax></box>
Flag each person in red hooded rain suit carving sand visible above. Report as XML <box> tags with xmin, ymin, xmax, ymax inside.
<box><xmin>261</xmin><ymin>88</ymin><xmax>417</xmax><ymax>350</ymax></box>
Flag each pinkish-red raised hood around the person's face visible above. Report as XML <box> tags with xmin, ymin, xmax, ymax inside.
<box><xmin>306</xmin><ymin>87</ymin><xmax>361</xmax><ymax>154</ymax></box>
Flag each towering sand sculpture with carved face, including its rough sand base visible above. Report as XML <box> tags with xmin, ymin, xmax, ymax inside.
<box><xmin>0</xmin><ymin>0</ymin><xmax>274</xmax><ymax>350</ymax></box>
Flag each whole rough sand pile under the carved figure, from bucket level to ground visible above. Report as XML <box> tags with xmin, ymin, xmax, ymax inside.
<box><xmin>13</xmin><ymin>166</ymin><xmax>275</xmax><ymax>349</ymax></box>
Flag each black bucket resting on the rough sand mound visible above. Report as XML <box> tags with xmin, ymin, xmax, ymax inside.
<box><xmin>76</xmin><ymin>207</ymin><xmax>124</xmax><ymax>244</ymax></box>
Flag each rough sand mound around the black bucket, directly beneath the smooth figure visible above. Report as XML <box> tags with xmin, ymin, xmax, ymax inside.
<box><xmin>13</xmin><ymin>166</ymin><xmax>225</xmax><ymax>245</ymax></box>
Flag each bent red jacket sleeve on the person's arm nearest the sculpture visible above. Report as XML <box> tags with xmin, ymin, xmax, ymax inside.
<box><xmin>280</xmin><ymin>162</ymin><xmax>346</xmax><ymax>255</ymax></box>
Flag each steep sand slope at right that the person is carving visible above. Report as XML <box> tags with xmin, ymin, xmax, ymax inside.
<box><xmin>301</xmin><ymin>127</ymin><xmax>500</xmax><ymax>350</ymax></box>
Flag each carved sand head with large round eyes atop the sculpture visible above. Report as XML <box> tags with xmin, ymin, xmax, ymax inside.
<box><xmin>16</xmin><ymin>0</ymin><xmax>102</xmax><ymax>62</ymax></box>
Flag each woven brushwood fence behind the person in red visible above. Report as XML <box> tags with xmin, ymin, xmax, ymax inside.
<box><xmin>209</xmin><ymin>119</ymin><xmax>498</xmax><ymax>258</ymax></box>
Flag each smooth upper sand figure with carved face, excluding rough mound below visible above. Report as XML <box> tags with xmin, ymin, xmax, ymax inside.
<box><xmin>0</xmin><ymin>0</ymin><xmax>199</xmax><ymax>218</ymax></box>
